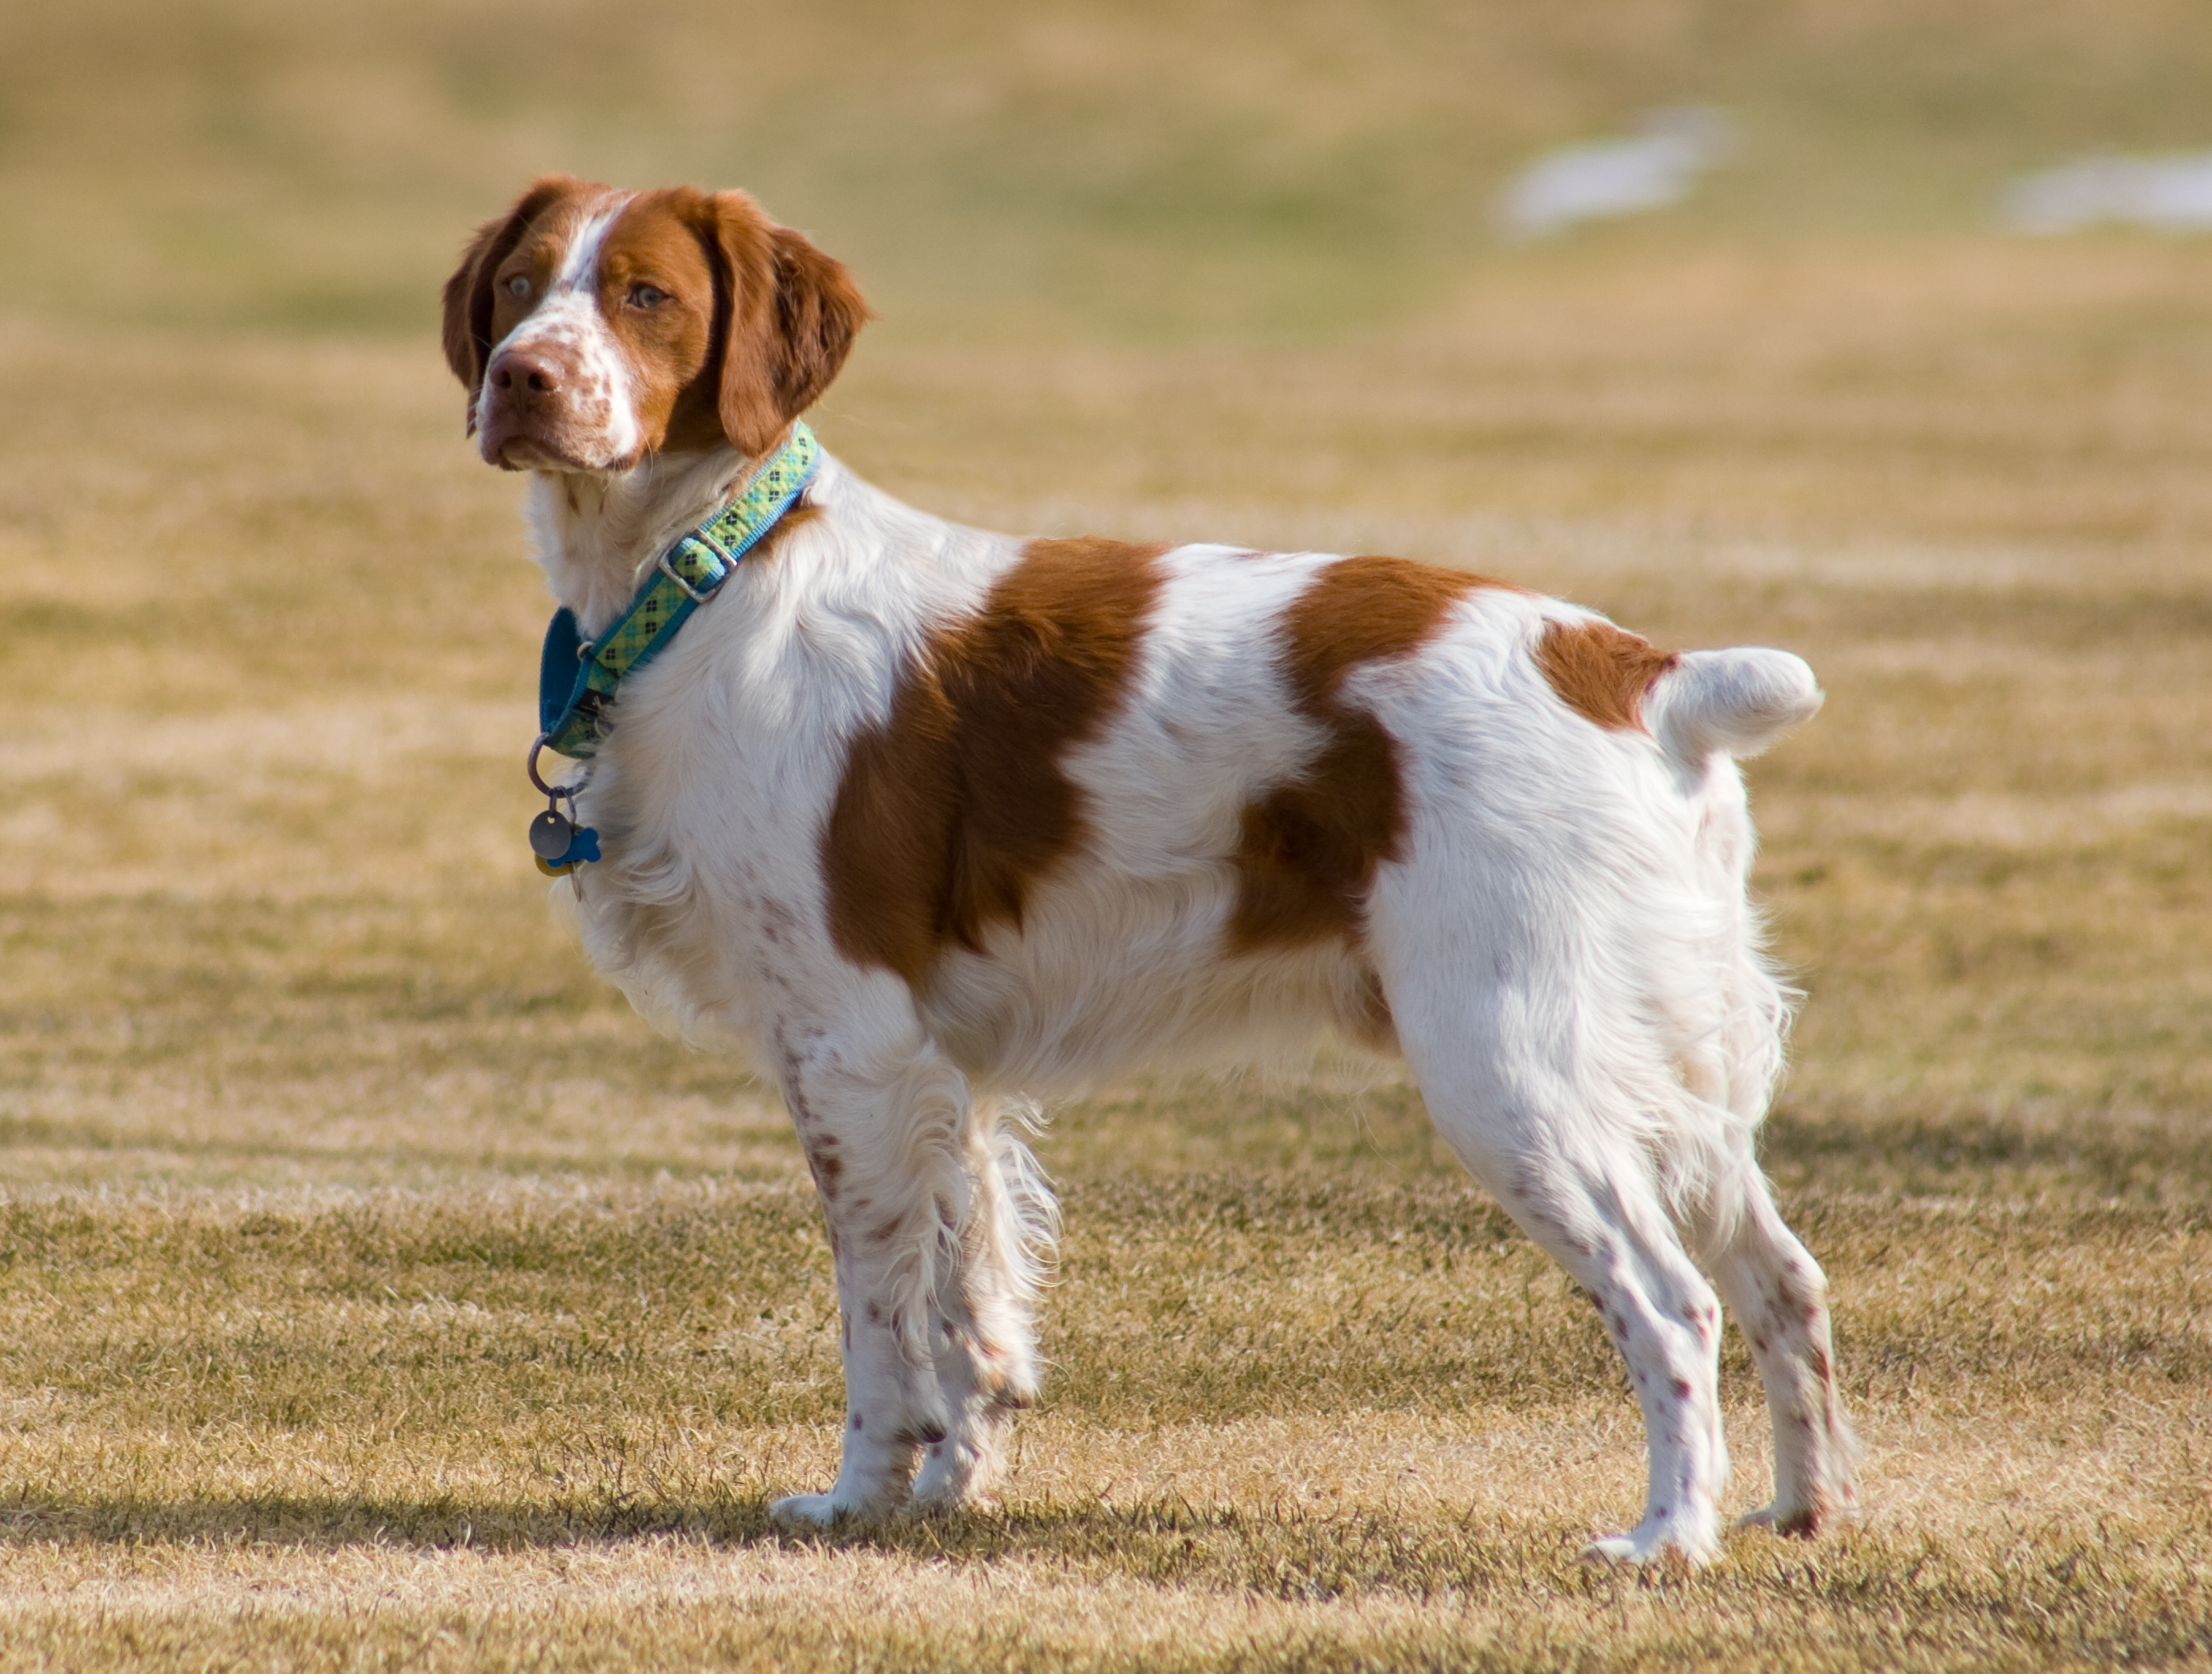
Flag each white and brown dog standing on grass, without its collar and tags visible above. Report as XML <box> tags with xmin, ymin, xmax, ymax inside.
<box><xmin>445</xmin><ymin>179</ymin><xmax>1854</xmax><ymax>1559</ymax></box>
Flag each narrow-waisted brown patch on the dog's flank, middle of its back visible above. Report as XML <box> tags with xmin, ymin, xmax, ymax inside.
<box><xmin>1230</xmin><ymin>557</ymin><xmax>1499</xmax><ymax>953</ymax></box>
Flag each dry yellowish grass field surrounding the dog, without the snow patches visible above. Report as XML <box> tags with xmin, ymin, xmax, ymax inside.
<box><xmin>0</xmin><ymin>0</ymin><xmax>2212</xmax><ymax>1669</ymax></box>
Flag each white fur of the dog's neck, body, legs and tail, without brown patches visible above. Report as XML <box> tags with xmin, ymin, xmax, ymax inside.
<box><xmin>479</xmin><ymin>303</ymin><xmax>1851</xmax><ymax>1559</ymax></box>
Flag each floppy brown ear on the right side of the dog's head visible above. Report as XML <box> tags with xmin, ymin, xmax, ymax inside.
<box><xmin>708</xmin><ymin>193</ymin><xmax>869</xmax><ymax>453</ymax></box>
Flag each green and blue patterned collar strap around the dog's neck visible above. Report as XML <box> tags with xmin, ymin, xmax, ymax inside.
<box><xmin>537</xmin><ymin>420</ymin><xmax>820</xmax><ymax>761</ymax></box>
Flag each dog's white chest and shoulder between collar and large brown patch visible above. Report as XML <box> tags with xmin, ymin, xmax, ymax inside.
<box><xmin>557</xmin><ymin>520</ymin><xmax>999</xmax><ymax>1050</ymax></box>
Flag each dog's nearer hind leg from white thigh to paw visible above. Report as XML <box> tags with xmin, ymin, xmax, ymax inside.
<box><xmin>1370</xmin><ymin>866</ymin><xmax>1769</xmax><ymax>1564</ymax></box>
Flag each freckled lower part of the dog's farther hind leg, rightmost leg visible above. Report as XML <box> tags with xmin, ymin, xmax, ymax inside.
<box><xmin>1712</xmin><ymin>1172</ymin><xmax>1858</xmax><ymax>1534</ymax></box>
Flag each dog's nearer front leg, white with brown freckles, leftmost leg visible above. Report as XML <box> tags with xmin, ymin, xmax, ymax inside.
<box><xmin>772</xmin><ymin>1033</ymin><xmax>971</xmax><ymax>1523</ymax></box>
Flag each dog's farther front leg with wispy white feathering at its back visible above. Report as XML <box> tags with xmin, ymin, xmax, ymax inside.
<box><xmin>914</xmin><ymin>1099</ymin><xmax>1060</xmax><ymax>1511</ymax></box>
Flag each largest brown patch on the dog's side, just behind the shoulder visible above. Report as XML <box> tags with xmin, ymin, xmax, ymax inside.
<box><xmin>823</xmin><ymin>535</ymin><xmax>1168</xmax><ymax>986</ymax></box>
